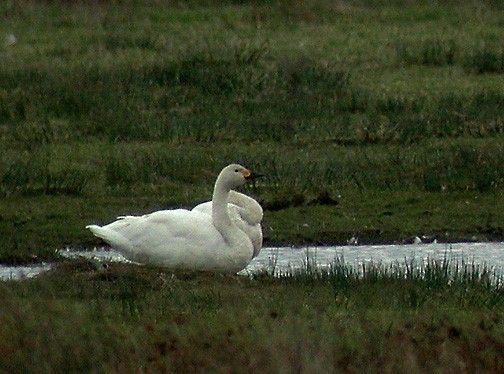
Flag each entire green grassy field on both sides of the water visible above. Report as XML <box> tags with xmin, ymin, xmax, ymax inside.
<box><xmin>0</xmin><ymin>0</ymin><xmax>504</xmax><ymax>373</ymax></box>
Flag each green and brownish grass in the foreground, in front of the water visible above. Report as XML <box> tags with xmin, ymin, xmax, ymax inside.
<box><xmin>0</xmin><ymin>259</ymin><xmax>504</xmax><ymax>373</ymax></box>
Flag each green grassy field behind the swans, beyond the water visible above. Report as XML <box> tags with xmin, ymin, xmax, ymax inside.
<box><xmin>0</xmin><ymin>0</ymin><xmax>504</xmax><ymax>262</ymax></box>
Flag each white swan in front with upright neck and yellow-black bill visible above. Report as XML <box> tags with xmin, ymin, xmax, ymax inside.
<box><xmin>86</xmin><ymin>164</ymin><xmax>262</xmax><ymax>272</ymax></box>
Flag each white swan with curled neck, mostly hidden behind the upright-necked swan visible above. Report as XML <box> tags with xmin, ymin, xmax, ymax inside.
<box><xmin>193</xmin><ymin>191</ymin><xmax>263</xmax><ymax>257</ymax></box>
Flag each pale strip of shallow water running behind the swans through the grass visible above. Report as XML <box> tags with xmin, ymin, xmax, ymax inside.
<box><xmin>0</xmin><ymin>243</ymin><xmax>504</xmax><ymax>280</ymax></box>
